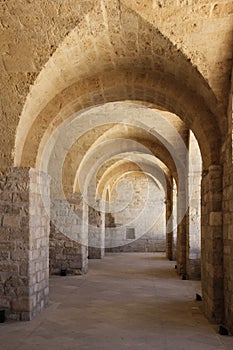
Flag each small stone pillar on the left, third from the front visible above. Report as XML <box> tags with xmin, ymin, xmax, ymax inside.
<box><xmin>88</xmin><ymin>206</ymin><xmax>105</xmax><ymax>259</ymax></box>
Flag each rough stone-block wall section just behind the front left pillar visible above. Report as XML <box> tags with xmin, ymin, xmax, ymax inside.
<box><xmin>49</xmin><ymin>195</ymin><xmax>87</xmax><ymax>275</ymax></box>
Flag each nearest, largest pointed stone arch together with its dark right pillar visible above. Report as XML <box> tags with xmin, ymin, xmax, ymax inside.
<box><xmin>0</xmin><ymin>2</ymin><xmax>229</xmax><ymax>328</ymax></box>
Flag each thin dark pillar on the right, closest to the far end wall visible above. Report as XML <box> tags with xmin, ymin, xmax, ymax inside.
<box><xmin>166</xmin><ymin>186</ymin><xmax>173</xmax><ymax>260</ymax></box>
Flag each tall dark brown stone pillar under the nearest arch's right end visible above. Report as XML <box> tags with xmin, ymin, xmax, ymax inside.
<box><xmin>201</xmin><ymin>165</ymin><xmax>224</xmax><ymax>322</ymax></box>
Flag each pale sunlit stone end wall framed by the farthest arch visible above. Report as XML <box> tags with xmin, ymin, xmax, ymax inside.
<box><xmin>105</xmin><ymin>172</ymin><xmax>166</xmax><ymax>252</ymax></box>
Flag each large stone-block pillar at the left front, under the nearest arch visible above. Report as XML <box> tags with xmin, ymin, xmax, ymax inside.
<box><xmin>0</xmin><ymin>168</ymin><xmax>50</xmax><ymax>321</ymax></box>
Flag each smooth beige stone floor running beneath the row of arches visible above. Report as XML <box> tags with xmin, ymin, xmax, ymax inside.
<box><xmin>0</xmin><ymin>253</ymin><xmax>233</xmax><ymax>350</ymax></box>
